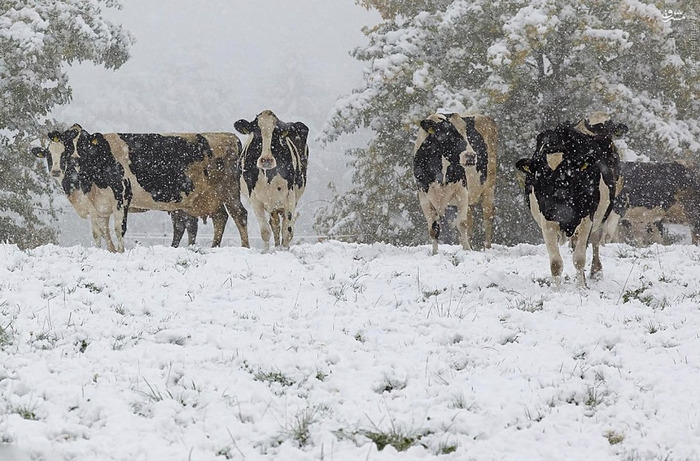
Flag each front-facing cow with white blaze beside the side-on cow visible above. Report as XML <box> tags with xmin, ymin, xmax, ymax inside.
<box><xmin>234</xmin><ymin>110</ymin><xmax>309</xmax><ymax>252</ymax></box>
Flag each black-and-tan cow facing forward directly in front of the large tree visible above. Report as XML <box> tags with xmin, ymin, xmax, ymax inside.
<box><xmin>413</xmin><ymin>113</ymin><xmax>498</xmax><ymax>254</ymax></box>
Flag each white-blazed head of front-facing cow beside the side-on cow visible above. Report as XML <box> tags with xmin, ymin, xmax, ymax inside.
<box><xmin>233</xmin><ymin>110</ymin><xmax>309</xmax><ymax>170</ymax></box>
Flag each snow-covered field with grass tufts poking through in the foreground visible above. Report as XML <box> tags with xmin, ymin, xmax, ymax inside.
<box><xmin>0</xmin><ymin>242</ymin><xmax>700</xmax><ymax>461</ymax></box>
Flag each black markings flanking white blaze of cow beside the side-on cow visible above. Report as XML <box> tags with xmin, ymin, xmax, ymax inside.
<box><xmin>234</xmin><ymin>117</ymin><xmax>309</xmax><ymax>191</ymax></box>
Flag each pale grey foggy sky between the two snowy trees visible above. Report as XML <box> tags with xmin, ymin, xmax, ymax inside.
<box><xmin>52</xmin><ymin>0</ymin><xmax>379</xmax><ymax>247</ymax></box>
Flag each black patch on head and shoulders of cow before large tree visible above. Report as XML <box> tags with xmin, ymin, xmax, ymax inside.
<box><xmin>413</xmin><ymin>119</ymin><xmax>467</xmax><ymax>192</ymax></box>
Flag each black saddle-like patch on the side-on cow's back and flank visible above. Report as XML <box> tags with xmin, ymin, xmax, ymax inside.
<box><xmin>119</xmin><ymin>133</ymin><xmax>213</xmax><ymax>203</ymax></box>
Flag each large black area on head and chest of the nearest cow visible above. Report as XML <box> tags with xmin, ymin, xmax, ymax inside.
<box><xmin>516</xmin><ymin>124</ymin><xmax>617</xmax><ymax>237</ymax></box>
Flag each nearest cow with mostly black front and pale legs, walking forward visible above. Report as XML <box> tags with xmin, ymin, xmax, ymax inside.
<box><xmin>515</xmin><ymin>121</ymin><xmax>627</xmax><ymax>287</ymax></box>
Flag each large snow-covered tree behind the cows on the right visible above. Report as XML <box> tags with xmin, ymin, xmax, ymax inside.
<box><xmin>317</xmin><ymin>0</ymin><xmax>700</xmax><ymax>244</ymax></box>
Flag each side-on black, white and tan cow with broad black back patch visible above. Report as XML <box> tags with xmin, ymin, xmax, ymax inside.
<box><xmin>35</xmin><ymin>124</ymin><xmax>249</xmax><ymax>251</ymax></box>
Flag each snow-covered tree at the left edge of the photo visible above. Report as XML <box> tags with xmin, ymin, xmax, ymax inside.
<box><xmin>0</xmin><ymin>0</ymin><xmax>132</xmax><ymax>247</ymax></box>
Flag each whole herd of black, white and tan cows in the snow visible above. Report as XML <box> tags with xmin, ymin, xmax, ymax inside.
<box><xmin>32</xmin><ymin>110</ymin><xmax>700</xmax><ymax>285</ymax></box>
